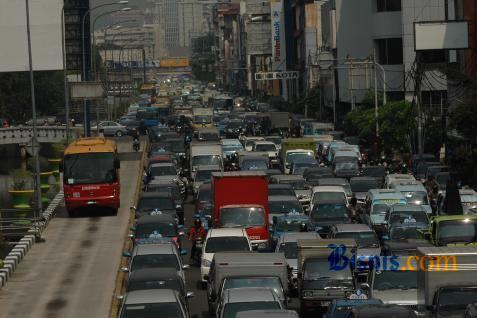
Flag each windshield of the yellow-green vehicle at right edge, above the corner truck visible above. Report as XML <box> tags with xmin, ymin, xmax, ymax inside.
<box><xmin>438</xmin><ymin>220</ymin><xmax>477</xmax><ymax>245</ymax></box>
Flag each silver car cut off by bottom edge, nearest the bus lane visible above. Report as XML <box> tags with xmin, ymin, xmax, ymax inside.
<box><xmin>119</xmin><ymin>289</ymin><xmax>189</xmax><ymax>318</ymax></box>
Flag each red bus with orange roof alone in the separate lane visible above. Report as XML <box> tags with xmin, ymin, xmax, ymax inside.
<box><xmin>61</xmin><ymin>137</ymin><xmax>120</xmax><ymax>216</ymax></box>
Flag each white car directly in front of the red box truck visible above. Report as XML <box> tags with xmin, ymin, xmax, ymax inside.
<box><xmin>200</xmin><ymin>228</ymin><xmax>252</xmax><ymax>283</ymax></box>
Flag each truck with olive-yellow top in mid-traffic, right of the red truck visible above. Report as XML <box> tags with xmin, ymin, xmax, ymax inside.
<box><xmin>280</xmin><ymin>138</ymin><xmax>316</xmax><ymax>174</ymax></box>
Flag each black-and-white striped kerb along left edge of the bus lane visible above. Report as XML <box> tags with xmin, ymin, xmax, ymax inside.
<box><xmin>0</xmin><ymin>190</ymin><xmax>63</xmax><ymax>289</ymax></box>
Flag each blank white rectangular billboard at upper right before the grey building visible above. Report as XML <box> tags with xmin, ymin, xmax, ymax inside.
<box><xmin>414</xmin><ymin>21</ymin><xmax>469</xmax><ymax>51</ymax></box>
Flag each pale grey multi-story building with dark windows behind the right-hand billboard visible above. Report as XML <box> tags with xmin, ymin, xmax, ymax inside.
<box><xmin>321</xmin><ymin>0</ymin><xmax>453</xmax><ymax>110</ymax></box>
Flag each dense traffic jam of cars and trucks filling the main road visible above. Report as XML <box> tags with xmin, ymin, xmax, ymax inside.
<box><xmin>97</xmin><ymin>78</ymin><xmax>477</xmax><ymax>318</ymax></box>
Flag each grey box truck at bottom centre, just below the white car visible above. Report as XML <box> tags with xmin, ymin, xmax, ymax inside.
<box><xmin>207</xmin><ymin>252</ymin><xmax>289</xmax><ymax>313</ymax></box>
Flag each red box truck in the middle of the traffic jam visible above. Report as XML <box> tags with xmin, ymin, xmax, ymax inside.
<box><xmin>212</xmin><ymin>171</ymin><xmax>270</xmax><ymax>248</ymax></box>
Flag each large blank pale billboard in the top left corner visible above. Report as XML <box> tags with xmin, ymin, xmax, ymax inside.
<box><xmin>0</xmin><ymin>0</ymin><xmax>63</xmax><ymax>72</ymax></box>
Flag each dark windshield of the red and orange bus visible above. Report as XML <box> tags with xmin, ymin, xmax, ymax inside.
<box><xmin>63</xmin><ymin>152</ymin><xmax>117</xmax><ymax>185</ymax></box>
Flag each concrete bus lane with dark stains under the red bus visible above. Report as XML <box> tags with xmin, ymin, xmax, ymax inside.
<box><xmin>0</xmin><ymin>138</ymin><xmax>140</xmax><ymax>318</ymax></box>
